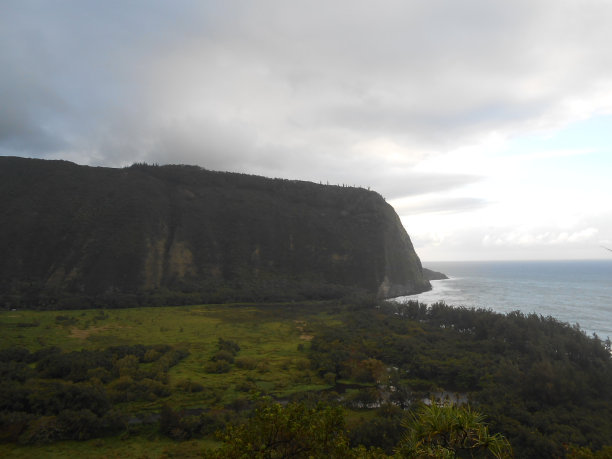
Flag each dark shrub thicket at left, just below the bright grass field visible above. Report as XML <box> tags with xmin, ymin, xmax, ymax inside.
<box><xmin>0</xmin><ymin>345</ymin><xmax>187</xmax><ymax>444</ymax></box>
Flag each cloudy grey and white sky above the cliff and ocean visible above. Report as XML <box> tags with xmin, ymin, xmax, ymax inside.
<box><xmin>0</xmin><ymin>0</ymin><xmax>612</xmax><ymax>263</ymax></box>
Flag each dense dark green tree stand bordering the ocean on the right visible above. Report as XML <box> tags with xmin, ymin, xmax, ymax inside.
<box><xmin>310</xmin><ymin>303</ymin><xmax>612</xmax><ymax>457</ymax></box>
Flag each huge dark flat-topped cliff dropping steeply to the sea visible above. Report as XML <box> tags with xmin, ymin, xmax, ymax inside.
<box><xmin>0</xmin><ymin>157</ymin><xmax>430</xmax><ymax>307</ymax></box>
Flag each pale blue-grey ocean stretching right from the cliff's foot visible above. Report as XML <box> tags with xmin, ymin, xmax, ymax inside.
<box><xmin>397</xmin><ymin>259</ymin><xmax>612</xmax><ymax>340</ymax></box>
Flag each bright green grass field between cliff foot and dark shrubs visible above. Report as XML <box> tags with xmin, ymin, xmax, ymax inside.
<box><xmin>0</xmin><ymin>303</ymin><xmax>335</xmax><ymax>398</ymax></box>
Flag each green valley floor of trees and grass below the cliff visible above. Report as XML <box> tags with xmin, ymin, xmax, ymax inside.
<box><xmin>0</xmin><ymin>297</ymin><xmax>612</xmax><ymax>458</ymax></box>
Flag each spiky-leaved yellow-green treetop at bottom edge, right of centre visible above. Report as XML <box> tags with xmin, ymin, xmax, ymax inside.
<box><xmin>397</xmin><ymin>400</ymin><xmax>512</xmax><ymax>459</ymax></box>
